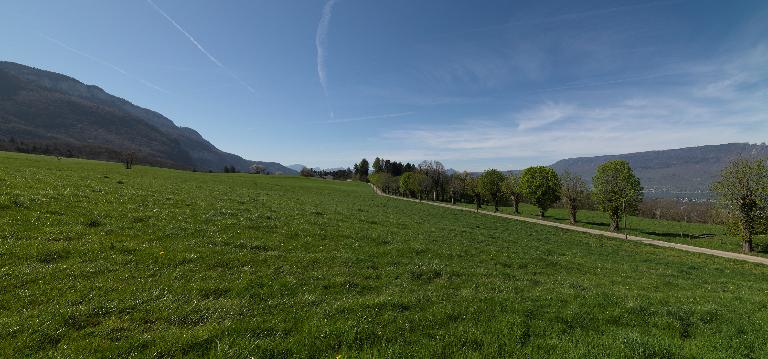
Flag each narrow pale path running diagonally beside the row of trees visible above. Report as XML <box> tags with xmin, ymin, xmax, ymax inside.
<box><xmin>371</xmin><ymin>186</ymin><xmax>768</xmax><ymax>264</ymax></box>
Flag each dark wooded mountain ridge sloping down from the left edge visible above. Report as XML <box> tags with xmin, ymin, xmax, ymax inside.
<box><xmin>0</xmin><ymin>62</ymin><xmax>297</xmax><ymax>175</ymax></box>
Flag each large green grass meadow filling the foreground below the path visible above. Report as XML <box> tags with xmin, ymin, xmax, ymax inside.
<box><xmin>0</xmin><ymin>152</ymin><xmax>768</xmax><ymax>358</ymax></box>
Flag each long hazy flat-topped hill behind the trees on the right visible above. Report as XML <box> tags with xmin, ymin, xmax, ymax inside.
<box><xmin>551</xmin><ymin>143</ymin><xmax>768</xmax><ymax>198</ymax></box>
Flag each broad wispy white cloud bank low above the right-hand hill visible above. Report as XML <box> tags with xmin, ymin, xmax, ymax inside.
<box><xmin>381</xmin><ymin>44</ymin><xmax>768</xmax><ymax>170</ymax></box>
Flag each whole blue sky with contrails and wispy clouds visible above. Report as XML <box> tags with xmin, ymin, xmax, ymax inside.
<box><xmin>0</xmin><ymin>0</ymin><xmax>768</xmax><ymax>170</ymax></box>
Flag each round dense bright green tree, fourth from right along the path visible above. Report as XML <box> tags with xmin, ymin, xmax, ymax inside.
<box><xmin>519</xmin><ymin>166</ymin><xmax>560</xmax><ymax>218</ymax></box>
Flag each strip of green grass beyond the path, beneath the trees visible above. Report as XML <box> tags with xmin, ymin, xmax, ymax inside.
<box><xmin>450</xmin><ymin>203</ymin><xmax>768</xmax><ymax>257</ymax></box>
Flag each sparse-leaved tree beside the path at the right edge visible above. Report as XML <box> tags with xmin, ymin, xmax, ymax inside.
<box><xmin>712</xmin><ymin>159</ymin><xmax>768</xmax><ymax>253</ymax></box>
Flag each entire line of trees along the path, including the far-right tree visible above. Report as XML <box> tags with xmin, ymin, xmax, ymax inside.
<box><xmin>364</xmin><ymin>158</ymin><xmax>768</xmax><ymax>252</ymax></box>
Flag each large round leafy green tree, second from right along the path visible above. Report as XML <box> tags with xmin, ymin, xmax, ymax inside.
<box><xmin>592</xmin><ymin>160</ymin><xmax>643</xmax><ymax>231</ymax></box>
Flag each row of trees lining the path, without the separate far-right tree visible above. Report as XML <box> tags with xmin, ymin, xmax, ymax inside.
<box><xmin>368</xmin><ymin>159</ymin><xmax>643</xmax><ymax>230</ymax></box>
